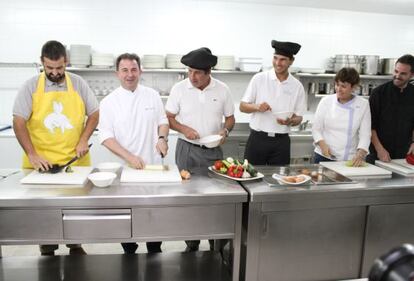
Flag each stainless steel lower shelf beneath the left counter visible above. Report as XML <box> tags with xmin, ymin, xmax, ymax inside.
<box><xmin>0</xmin><ymin>252</ymin><xmax>231</xmax><ymax>281</ymax></box>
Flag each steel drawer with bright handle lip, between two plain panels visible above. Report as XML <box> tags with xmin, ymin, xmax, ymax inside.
<box><xmin>63</xmin><ymin>209</ymin><xmax>131</xmax><ymax>239</ymax></box>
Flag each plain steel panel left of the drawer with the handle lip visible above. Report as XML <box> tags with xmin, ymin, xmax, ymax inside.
<box><xmin>0</xmin><ymin>209</ymin><xmax>62</xmax><ymax>240</ymax></box>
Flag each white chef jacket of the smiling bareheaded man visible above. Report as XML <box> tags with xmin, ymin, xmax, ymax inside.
<box><xmin>98</xmin><ymin>84</ymin><xmax>168</xmax><ymax>164</ymax></box>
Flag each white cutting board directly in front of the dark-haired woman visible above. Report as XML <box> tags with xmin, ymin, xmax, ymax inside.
<box><xmin>320</xmin><ymin>161</ymin><xmax>392</xmax><ymax>178</ymax></box>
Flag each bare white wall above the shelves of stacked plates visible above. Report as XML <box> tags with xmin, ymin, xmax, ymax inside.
<box><xmin>0</xmin><ymin>0</ymin><xmax>414</xmax><ymax>67</ymax></box>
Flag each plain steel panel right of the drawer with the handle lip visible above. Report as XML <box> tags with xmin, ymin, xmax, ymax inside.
<box><xmin>132</xmin><ymin>204</ymin><xmax>236</xmax><ymax>238</ymax></box>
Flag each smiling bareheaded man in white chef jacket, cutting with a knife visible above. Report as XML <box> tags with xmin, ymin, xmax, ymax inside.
<box><xmin>98</xmin><ymin>53</ymin><xmax>169</xmax><ymax>254</ymax></box>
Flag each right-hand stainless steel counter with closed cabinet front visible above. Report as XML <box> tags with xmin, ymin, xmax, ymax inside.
<box><xmin>242</xmin><ymin>167</ymin><xmax>414</xmax><ymax>281</ymax></box>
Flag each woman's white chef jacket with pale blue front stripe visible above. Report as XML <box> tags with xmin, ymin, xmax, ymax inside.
<box><xmin>312</xmin><ymin>94</ymin><xmax>371</xmax><ymax>160</ymax></box>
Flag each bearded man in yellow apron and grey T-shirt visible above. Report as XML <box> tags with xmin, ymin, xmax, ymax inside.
<box><xmin>13</xmin><ymin>41</ymin><xmax>99</xmax><ymax>255</ymax></box>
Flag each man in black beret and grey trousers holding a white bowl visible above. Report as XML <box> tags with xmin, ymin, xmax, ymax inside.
<box><xmin>165</xmin><ymin>48</ymin><xmax>235</xmax><ymax>251</ymax></box>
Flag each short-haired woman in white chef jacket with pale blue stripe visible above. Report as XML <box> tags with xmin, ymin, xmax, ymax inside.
<box><xmin>312</xmin><ymin>67</ymin><xmax>371</xmax><ymax>166</ymax></box>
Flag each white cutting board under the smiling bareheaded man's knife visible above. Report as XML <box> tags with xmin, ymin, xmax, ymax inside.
<box><xmin>121</xmin><ymin>165</ymin><xmax>181</xmax><ymax>182</ymax></box>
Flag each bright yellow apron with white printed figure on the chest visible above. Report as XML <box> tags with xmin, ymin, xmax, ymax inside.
<box><xmin>23</xmin><ymin>72</ymin><xmax>90</xmax><ymax>168</ymax></box>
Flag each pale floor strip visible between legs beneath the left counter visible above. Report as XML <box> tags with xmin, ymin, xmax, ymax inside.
<box><xmin>1</xmin><ymin>240</ymin><xmax>209</xmax><ymax>257</ymax></box>
